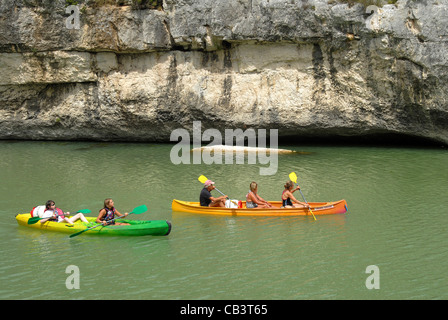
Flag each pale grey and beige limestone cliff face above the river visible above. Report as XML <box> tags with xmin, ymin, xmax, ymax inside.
<box><xmin>0</xmin><ymin>0</ymin><xmax>448</xmax><ymax>144</ymax></box>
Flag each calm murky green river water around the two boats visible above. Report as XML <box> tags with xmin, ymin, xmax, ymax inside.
<box><xmin>0</xmin><ymin>141</ymin><xmax>448</xmax><ymax>300</ymax></box>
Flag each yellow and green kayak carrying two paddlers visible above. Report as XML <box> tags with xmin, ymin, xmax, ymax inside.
<box><xmin>16</xmin><ymin>213</ymin><xmax>171</xmax><ymax>236</ymax></box>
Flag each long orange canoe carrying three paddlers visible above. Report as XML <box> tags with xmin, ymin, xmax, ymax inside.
<box><xmin>171</xmin><ymin>199</ymin><xmax>347</xmax><ymax>217</ymax></box>
